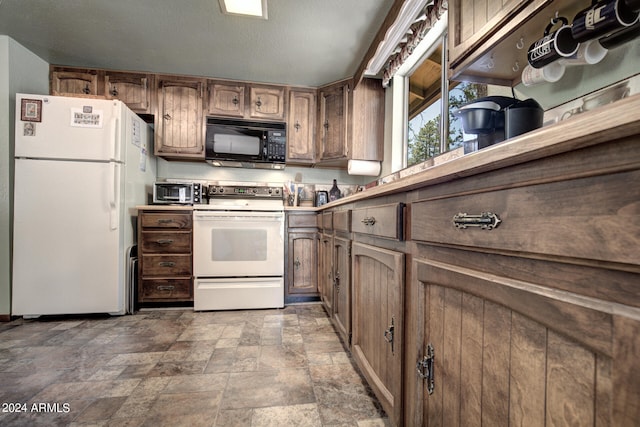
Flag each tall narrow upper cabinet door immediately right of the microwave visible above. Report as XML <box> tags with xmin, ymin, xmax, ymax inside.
<box><xmin>287</xmin><ymin>90</ymin><xmax>316</xmax><ymax>163</ymax></box>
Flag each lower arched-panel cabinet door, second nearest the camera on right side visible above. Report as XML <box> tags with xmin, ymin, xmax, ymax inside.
<box><xmin>351</xmin><ymin>242</ymin><xmax>404</xmax><ymax>425</ymax></box>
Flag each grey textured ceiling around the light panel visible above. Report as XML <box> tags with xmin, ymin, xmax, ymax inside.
<box><xmin>0</xmin><ymin>0</ymin><xmax>393</xmax><ymax>86</ymax></box>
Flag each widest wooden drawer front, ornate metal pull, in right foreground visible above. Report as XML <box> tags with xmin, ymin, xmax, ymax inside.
<box><xmin>411</xmin><ymin>171</ymin><xmax>640</xmax><ymax>264</ymax></box>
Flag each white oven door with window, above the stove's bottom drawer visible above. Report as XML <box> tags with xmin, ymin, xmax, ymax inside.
<box><xmin>193</xmin><ymin>211</ymin><xmax>284</xmax><ymax>277</ymax></box>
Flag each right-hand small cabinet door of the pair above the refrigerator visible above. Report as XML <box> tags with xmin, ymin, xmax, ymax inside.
<box><xmin>104</xmin><ymin>71</ymin><xmax>153</xmax><ymax>114</ymax></box>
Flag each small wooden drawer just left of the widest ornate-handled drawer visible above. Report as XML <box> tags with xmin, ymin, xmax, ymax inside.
<box><xmin>351</xmin><ymin>203</ymin><xmax>404</xmax><ymax>240</ymax></box>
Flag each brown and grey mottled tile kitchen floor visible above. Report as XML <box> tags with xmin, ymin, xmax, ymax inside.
<box><xmin>0</xmin><ymin>304</ymin><xmax>388</xmax><ymax>427</ymax></box>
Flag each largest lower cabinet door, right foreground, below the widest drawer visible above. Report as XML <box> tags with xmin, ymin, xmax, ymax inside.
<box><xmin>406</xmin><ymin>260</ymin><xmax>640</xmax><ymax>426</ymax></box>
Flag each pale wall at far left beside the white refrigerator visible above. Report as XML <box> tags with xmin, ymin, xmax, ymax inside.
<box><xmin>0</xmin><ymin>35</ymin><xmax>49</xmax><ymax>317</ymax></box>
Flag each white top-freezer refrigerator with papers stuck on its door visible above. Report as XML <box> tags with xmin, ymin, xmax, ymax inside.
<box><xmin>12</xmin><ymin>94</ymin><xmax>156</xmax><ymax>317</ymax></box>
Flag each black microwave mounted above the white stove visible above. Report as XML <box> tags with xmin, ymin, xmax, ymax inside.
<box><xmin>205</xmin><ymin>117</ymin><xmax>287</xmax><ymax>169</ymax></box>
